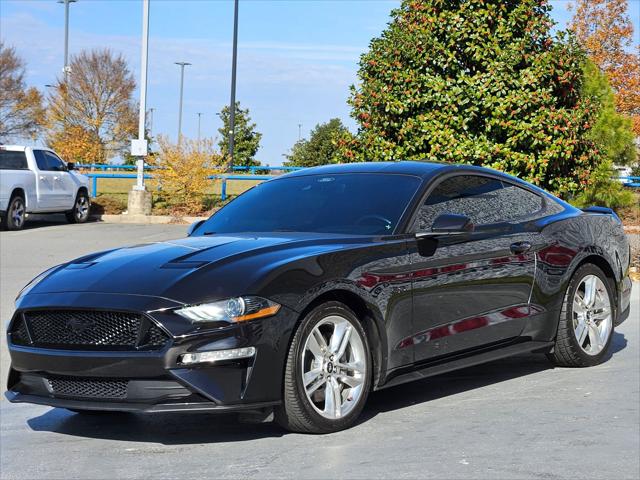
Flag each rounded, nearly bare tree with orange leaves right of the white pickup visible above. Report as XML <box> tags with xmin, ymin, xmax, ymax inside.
<box><xmin>47</xmin><ymin>49</ymin><xmax>137</xmax><ymax>163</ymax></box>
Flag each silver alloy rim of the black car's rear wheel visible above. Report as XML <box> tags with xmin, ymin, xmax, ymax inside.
<box><xmin>573</xmin><ymin>275</ymin><xmax>613</xmax><ymax>355</ymax></box>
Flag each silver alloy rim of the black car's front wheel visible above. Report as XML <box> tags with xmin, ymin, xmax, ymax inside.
<box><xmin>301</xmin><ymin>315</ymin><xmax>367</xmax><ymax>420</ymax></box>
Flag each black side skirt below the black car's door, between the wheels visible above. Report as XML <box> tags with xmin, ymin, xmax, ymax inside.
<box><xmin>376</xmin><ymin>341</ymin><xmax>553</xmax><ymax>390</ymax></box>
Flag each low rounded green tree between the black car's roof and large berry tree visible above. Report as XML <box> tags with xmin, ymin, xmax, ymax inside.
<box><xmin>285</xmin><ymin>118</ymin><xmax>349</xmax><ymax>167</ymax></box>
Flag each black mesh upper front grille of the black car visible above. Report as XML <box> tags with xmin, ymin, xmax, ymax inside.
<box><xmin>11</xmin><ymin>310</ymin><xmax>169</xmax><ymax>350</ymax></box>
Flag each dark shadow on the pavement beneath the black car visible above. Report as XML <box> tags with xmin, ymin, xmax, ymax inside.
<box><xmin>27</xmin><ymin>332</ymin><xmax>627</xmax><ymax>445</ymax></box>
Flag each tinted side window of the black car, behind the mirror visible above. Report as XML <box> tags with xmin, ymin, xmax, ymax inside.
<box><xmin>413</xmin><ymin>175</ymin><xmax>544</xmax><ymax>231</ymax></box>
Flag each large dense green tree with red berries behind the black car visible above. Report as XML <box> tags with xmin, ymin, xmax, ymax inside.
<box><xmin>341</xmin><ymin>0</ymin><xmax>598</xmax><ymax>197</ymax></box>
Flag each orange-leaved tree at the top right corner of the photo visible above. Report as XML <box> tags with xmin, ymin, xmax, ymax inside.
<box><xmin>570</xmin><ymin>0</ymin><xmax>640</xmax><ymax>136</ymax></box>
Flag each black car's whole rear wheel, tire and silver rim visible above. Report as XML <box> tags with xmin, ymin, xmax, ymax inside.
<box><xmin>548</xmin><ymin>263</ymin><xmax>615</xmax><ymax>367</ymax></box>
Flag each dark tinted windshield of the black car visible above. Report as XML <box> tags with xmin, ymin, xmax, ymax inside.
<box><xmin>197</xmin><ymin>173</ymin><xmax>420</xmax><ymax>235</ymax></box>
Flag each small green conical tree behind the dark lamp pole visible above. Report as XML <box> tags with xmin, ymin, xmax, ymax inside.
<box><xmin>218</xmin><ymin>102</ymin><xmax>262</xmax><ymax>167</ymax></box>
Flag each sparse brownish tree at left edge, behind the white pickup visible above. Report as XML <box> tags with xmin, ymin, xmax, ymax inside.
<box><xmin>0</xmin><ymin>42</ymin><xmax>45</xmax><ymax>143</ymax></box>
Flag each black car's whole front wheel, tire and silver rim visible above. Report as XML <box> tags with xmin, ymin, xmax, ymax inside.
<box><xmin>275</xmin><ymin>302</ymin><xmax>373</xmax><ymax>433</ymax></box>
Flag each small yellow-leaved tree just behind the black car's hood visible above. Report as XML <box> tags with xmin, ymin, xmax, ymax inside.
<box><xmin>152</xmin><ymin>136</ymin><xmax>226</xmax><ymax>213</ymax></box>
